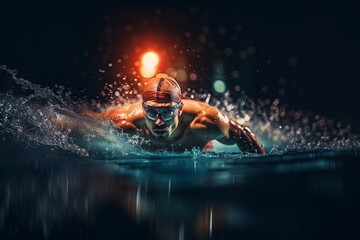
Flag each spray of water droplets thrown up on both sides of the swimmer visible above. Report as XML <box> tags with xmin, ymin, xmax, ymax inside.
<box><xmin>0</xmin><ymin>66</ymin><xmax>360</xmax><ymax>158</ymax></box>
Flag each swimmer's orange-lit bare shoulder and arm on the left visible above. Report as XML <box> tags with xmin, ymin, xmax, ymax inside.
<box><xmin>83</xmin><ymin>102</ymin><xmax>144</xmax><ymax>133</ymax></box>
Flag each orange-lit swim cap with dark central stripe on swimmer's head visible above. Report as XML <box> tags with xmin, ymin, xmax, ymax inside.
<box><xmin>143</xmin><ymin>73</ymin><xmax>181</xmax><ymax>103</ymax></box>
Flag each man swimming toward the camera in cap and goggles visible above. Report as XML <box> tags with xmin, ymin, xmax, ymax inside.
<box><xmin>85</xmin><ymin>74</ymin><xmax>265</xmax><ymax>154</ymax></box>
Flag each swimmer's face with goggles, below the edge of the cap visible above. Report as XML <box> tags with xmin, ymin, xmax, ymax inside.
<box><xmin>142</xmin><ymin>101</ymin><xmax>182</xmax><ymax>141</ymax></box>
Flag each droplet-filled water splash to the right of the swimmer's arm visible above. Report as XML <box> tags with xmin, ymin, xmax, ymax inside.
<box><xmin>188</xmin><ymin>90</ymin><xmax>360</xmax><ymax>154</ymax></box>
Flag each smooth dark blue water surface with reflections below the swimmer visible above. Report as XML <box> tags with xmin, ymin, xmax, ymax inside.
<box><xmin>0</xmin><ymin>150</ymin><xmax>360</xmax><ymax>239</ymax></box>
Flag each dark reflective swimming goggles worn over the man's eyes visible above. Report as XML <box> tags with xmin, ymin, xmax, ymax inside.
<box><xmin>142</xmin><ymin>102</ymin><xmax>181</xmax><ymax>121</ymax></box>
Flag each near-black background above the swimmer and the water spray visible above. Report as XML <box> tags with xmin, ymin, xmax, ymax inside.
<box><xmin>0</xmin><ymin>1</ymin><xmax>360</xmax><ymax>132</ymax></box>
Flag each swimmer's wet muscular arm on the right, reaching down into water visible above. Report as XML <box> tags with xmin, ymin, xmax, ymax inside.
<box><xmin>191</xmin><ymin>106</ymin><xmax>265</xmax><ymax>154</ymax></box>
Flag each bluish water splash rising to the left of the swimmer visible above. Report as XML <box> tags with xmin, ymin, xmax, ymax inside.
<box><xmin>0</xmin><ymin>66</ymin><xmax>146</xmax><ymax>158</ymax></box>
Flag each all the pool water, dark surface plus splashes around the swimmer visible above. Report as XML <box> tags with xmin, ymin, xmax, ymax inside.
<box><xmin>0</xmin><ymin>66</ymin><xmax>360</xmax><ymax>240</ymax></box>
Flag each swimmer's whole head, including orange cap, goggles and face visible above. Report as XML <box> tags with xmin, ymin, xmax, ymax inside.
<box><xmin>142</xmin><ymin>73</ymin><xmax>183</xmax><ymax>141</ymax></box>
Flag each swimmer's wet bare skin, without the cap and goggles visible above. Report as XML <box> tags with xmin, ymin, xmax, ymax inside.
<box><xmin>84</xmin><ymin>99</ymin><xmax>265</xmax><ymax>154</ymax></box>
